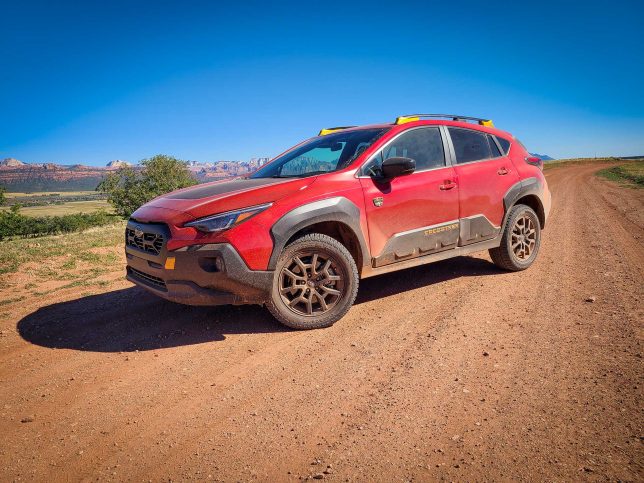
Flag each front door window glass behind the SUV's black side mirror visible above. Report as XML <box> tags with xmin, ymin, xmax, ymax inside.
<box><xmin>363</xmin><ymin>127</ymin><xmax>445</xmax><ymax>176</ymax></box>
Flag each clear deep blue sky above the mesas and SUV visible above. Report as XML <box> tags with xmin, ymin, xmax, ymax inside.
<box><xmin>0</xmin><ymin>0</ymin><xmax>644</xmax><ymax>165</ymax></box>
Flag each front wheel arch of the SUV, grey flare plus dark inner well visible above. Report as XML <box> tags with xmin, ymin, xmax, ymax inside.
<box><xmin>268</xmin><ymin>197</ymin><xmax>371</xmax><ymax>273</ymax></box>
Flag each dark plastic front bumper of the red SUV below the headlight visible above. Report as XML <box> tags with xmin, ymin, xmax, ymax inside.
<box><xmin>125</xmin><ymin>222</ymin><xmax>273</xmax><ymax>305</ymax></box>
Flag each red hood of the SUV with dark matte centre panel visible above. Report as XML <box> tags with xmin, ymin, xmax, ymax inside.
<box><xmin>132</xmin><ymin>178</ymin><xmax>315</xmax><ymax>221</ymax></box>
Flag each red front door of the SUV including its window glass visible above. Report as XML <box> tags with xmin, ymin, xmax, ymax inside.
<box><xmin>360</xmin><ymin>126</ymin><xmax>459</xmax><ymax>267</ymax></box>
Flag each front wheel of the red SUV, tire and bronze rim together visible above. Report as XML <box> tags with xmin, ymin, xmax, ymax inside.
<box><xmin>266</xmin><ymin>233</ymin><xmax>358</xmax><ymax>329</ymax></box>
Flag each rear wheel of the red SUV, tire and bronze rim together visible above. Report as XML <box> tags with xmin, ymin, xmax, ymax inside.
<box><xmin>490</xmin><ymin>205</ymin><xmax>541</xmax><ymax>272</ymax></box>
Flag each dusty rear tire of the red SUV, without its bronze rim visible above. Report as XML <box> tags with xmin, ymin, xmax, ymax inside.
<box><xmin>489</xmin><ymin>205</ymin><xmax>541</xmax><ymax>272</ymax></box>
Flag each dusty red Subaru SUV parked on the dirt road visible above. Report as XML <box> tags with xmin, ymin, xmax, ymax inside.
<box><xmin>125</xmin><ymin>114</ymin><xmax>550</xmax><ymax>329</ymax></box>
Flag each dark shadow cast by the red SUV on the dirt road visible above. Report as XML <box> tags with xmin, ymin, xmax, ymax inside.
<box><xmin>17</xmin><ymin>257</ymin><xmax>503</xmax><ymax>352</ymax></box>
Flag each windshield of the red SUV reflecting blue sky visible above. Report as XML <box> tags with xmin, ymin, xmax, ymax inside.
<box><xmin>250</xmin><ymin>128</ymin><xmax>387</xmax><ymax>178</ymax></box>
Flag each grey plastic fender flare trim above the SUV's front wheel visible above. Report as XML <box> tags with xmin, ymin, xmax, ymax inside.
<box><xmin>268</xmin><ymin>196</ymin><xmax>371</xmax><ymax>272</ymax></box>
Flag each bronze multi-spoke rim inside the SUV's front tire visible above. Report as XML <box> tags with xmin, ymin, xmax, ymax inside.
<box><xmin>279</xmin><ymin>251</ymin><xmax>346</xmax><ymax>317</ymax></box>
